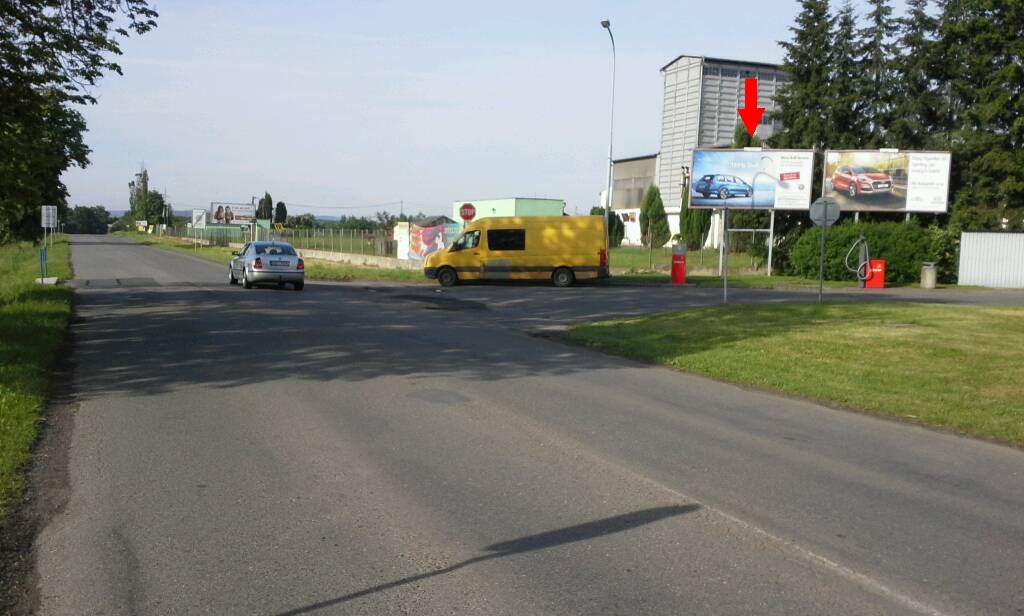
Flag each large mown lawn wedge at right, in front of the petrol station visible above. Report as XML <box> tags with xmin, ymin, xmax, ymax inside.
<box><xmin>565</xmin><ymin>303</ymin><xmax>1024</xmax><ymax>446</ymax></box>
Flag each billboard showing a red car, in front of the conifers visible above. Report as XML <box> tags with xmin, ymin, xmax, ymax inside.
<box><xmin>821</xmin><ymin>149</ymin><xmax>951</xmax><ymax>213</ymax></box>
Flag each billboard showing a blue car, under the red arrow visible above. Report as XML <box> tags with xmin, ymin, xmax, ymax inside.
<box><xmin>690</xmin><ymin>149</ymin><xmax>814</xmax><ymax>210</ymax></box>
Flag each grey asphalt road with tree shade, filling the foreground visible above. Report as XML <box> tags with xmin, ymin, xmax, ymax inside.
<box><xmin>37</xmin><ymin>236</ymin><xmax>1024</xmax><ymax>615</ymax></box>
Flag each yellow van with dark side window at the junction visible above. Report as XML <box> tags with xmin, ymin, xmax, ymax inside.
<box><xmin>423</xmin><ymin>216</ymin><xmax>608</xmax><ymax>287</ymax></box>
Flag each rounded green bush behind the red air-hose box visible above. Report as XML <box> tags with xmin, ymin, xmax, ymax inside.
<box><xmin>787</xmin><ymin>222</ymin><xmax>935</xmax><ymax>284</ymax></box>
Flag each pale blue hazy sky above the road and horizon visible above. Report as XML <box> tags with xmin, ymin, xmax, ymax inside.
<box><xmin>65</xmin><ymin>0</ymin><xmax>799</xmax><ymax>215</ymax></box>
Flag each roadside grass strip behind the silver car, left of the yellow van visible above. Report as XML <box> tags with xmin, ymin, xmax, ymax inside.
<box><xmin>117</xmin><ymin>232</ymin><xmax>432</xmax><ymax>282</ymax></box>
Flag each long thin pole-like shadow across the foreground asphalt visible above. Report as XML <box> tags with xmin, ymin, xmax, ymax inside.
<box><xmin>276</xmin><ymin>504</ymin><xmax>700</xmax><ymax>616</ymax></box>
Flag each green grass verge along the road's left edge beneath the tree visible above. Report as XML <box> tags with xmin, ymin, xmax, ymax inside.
<box><xmin>0</xmin><ymin>238</ymin><xmax>72</xmax><ymax>516</ymax></box>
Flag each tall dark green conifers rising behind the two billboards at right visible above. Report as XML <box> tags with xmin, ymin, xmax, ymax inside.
<box><xmin>769</xmin><ymin>0</ymin><xmax>1024</xmax><ymax>230</ymax></box>
